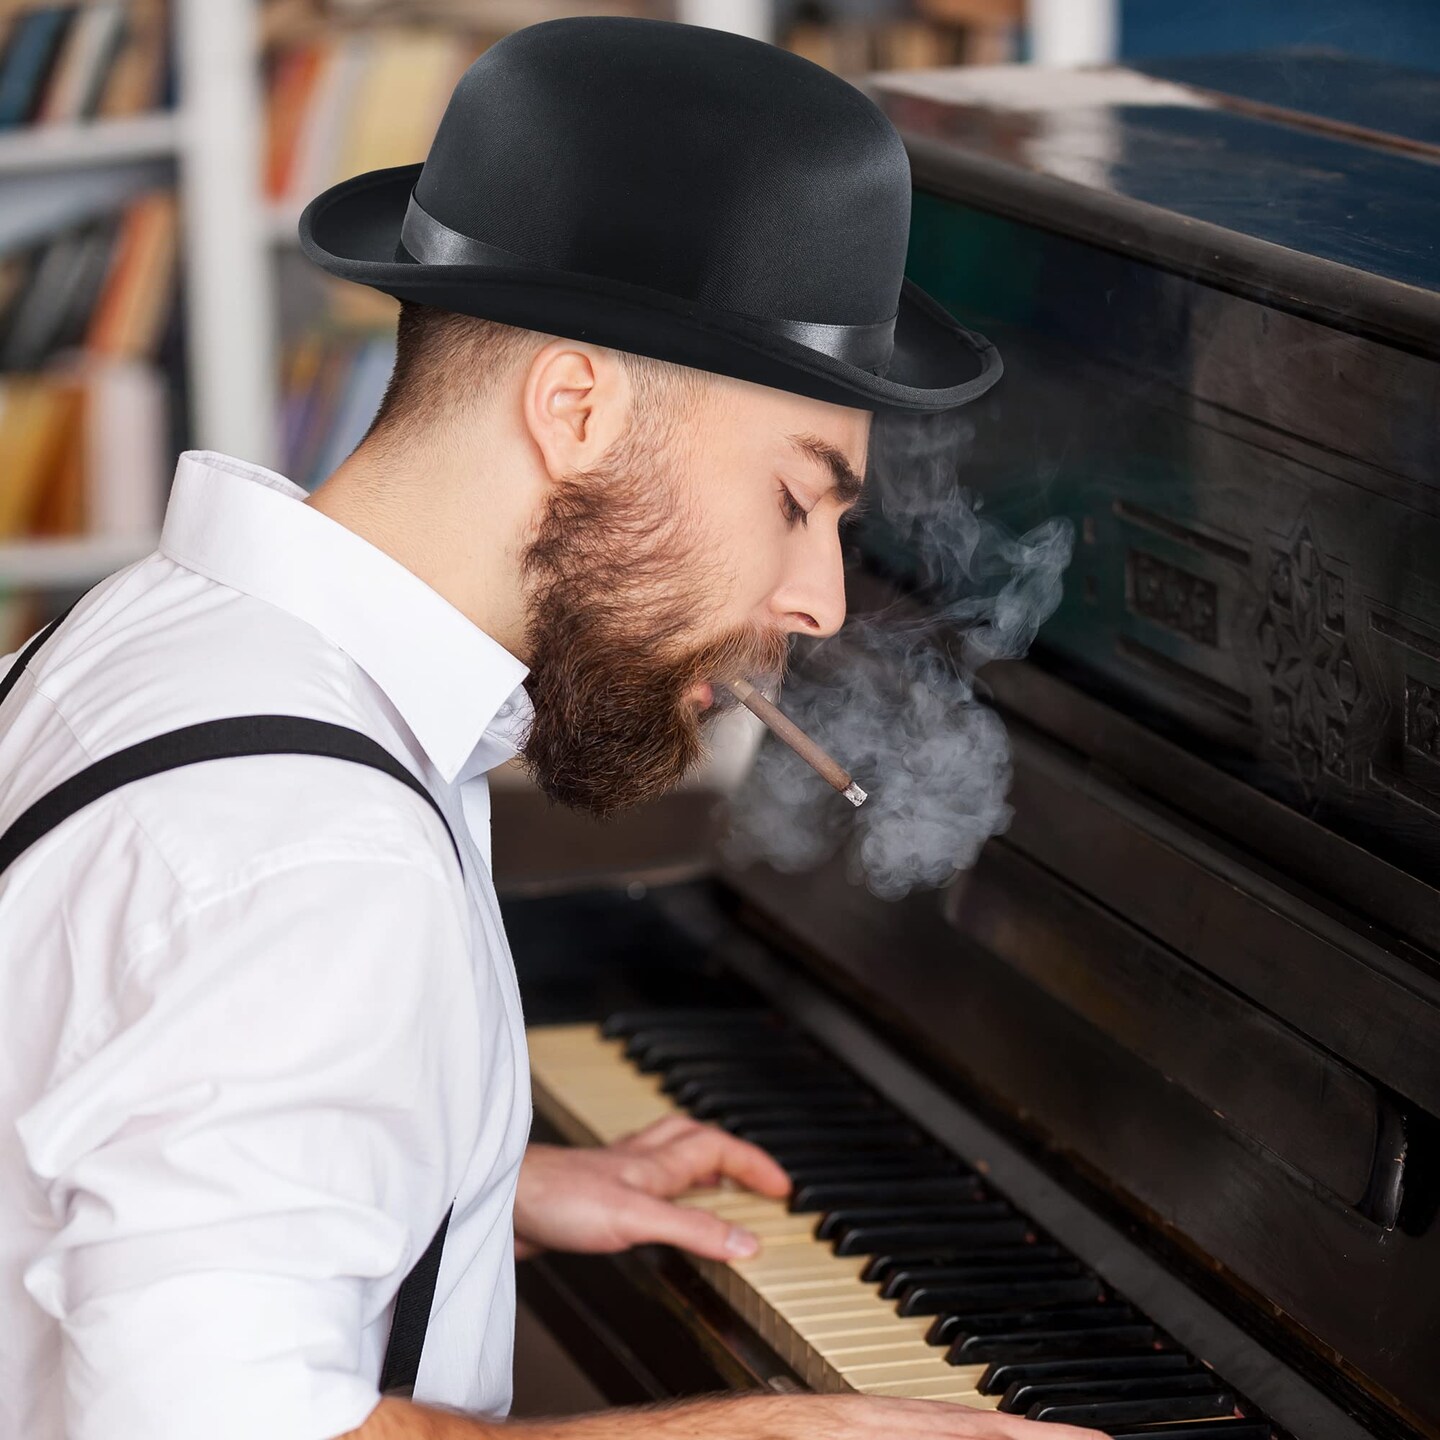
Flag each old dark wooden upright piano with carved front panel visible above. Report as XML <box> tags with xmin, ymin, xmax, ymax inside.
<box><xmin>497</xmin><ymin>53</ymin><xmax>1440</xmax><ymax>1440</ymax></box>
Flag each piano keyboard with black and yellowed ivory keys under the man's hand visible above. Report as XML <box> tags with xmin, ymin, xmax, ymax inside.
<box><xmin>528</xmin><ymin>1011</ymin><xmax>1273</xmax><ymax>1440</ymax></box>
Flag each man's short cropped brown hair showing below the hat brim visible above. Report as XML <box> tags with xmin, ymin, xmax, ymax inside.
<box><xmin>364</xmin><ymin>300</ymin><xmax>707</xmax><ymax>449</ymax></box>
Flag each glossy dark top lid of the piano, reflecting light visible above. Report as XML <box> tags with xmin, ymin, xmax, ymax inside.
<box><xmin>867</xmin><ymin>52</ymin><xmax>1440</xmax><ymax>350</ymax></box>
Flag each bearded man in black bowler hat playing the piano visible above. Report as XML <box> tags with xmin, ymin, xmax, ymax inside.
<box><xmin>0</xmin><ymin>11</ymin><xmax>1082</xmax><ymax>1440</ymax></box>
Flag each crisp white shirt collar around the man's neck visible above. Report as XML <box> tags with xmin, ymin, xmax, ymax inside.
<box><xmin>160</xmin><ymin>451</ymin><xmax>533</xmax><ymax>785</ymax></box>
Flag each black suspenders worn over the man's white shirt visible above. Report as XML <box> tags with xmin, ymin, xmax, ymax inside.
<box><xmin>0</xmin><ymin>624</ymin><xmax>464</xmax><ymax>1390</ymax></box>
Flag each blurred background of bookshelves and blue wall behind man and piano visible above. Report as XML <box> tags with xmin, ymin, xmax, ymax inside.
<box><xmin>0</xmin><ymin>0</ymin><xmax>1440</xmax><ymax>654</ymax></box>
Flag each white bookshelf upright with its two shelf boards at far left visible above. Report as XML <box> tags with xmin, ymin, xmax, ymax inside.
<box><xmin>0</xmin><ymin>0</ymin><xmax>278</xmax><ymax>619</ymax></box>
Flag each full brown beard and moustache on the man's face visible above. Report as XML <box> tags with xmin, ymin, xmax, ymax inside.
<box><xmin>523</xmin><ymin>420</ymin><xmax>788</xmax><ymax>816</ymax></box>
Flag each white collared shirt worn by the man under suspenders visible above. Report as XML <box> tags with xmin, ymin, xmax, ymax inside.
<box><xmin>0</xmin><ymin>451</ymin><xmax>531</xmax><ymax>1440</ymax></box>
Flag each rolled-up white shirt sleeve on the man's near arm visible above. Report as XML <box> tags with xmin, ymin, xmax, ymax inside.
<box><xmin>19</xmin><ymin>858</ymin><xmax>482</xmax><ymax>1440</ymax></box>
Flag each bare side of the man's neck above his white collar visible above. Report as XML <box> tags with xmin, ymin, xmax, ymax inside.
<box><xmin>305</xmin><ymin>446</ymin><xmax>527</xmax><ymax>660</ymax></box>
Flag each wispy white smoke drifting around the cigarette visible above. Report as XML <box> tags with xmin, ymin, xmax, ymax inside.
<box><xmin>721</xmin><ymin>412</ymin><xmax>1073</xmax><ymax>900</ymax></box>
